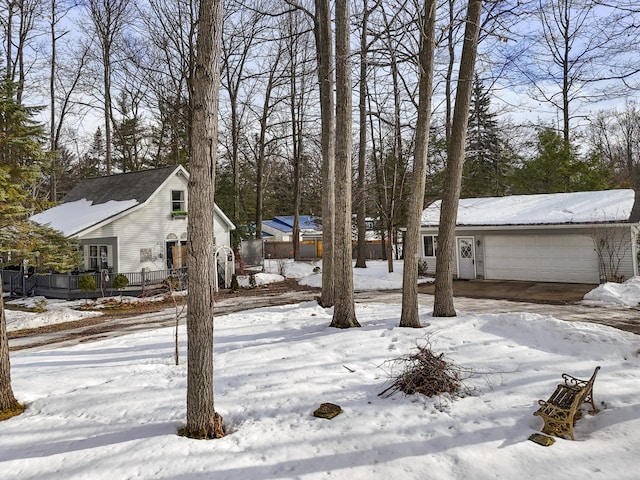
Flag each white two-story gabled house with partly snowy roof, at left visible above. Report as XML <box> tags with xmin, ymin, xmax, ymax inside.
<box><xmin>31</xmin><ymin>166</ymin><xmax>235</xmax><ymax>273</ymax></box>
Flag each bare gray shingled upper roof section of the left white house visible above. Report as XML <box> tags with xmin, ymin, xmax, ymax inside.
<box><xmin>62</xmin><ymin>165</ymin><xmax>177</xmax><ymax>204</ymax></box>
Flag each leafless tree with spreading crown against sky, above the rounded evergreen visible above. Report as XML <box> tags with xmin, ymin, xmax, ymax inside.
<box><xmin>526</xmin><ymin>0</ymin><xmax>640</xmax><ymax>144</ymax></box>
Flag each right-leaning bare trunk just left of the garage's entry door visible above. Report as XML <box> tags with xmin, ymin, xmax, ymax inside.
<box><xmin>433</xmin><ymin>0</ymin><xmax>482</xmax><ymax>317</ymax></box>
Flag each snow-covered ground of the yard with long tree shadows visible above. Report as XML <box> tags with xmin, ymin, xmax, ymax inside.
<box><xmin>0</xmin><ymin>262</ymin><xmax>640</xmax><ymax>480</ymax></box>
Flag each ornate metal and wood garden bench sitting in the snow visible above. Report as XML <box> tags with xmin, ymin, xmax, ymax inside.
<box><xmin>534</xmin><ymin>366</ymin><xmax>600</xmax><ymax>440</ymax></box>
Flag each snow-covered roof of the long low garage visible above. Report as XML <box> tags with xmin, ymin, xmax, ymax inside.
<box><xmin>422</xmin><ymin>189</ymin><xmax>635</xmax><ymax>226</ymax></box>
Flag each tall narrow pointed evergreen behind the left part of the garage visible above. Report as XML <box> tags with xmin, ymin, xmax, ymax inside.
<box><xmin>462</xmin><ymin>75</ymin><xmax>513</xmax><ymax>197</ymax></box>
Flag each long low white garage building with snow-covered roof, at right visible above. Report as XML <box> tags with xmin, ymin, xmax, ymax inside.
<box><xmin>421</xmin><ymin>189</ymin><xmax>640</xmax><ymax>284</ymax></box>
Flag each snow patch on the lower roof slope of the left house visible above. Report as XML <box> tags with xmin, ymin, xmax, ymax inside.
<box><xmin>31</xmin><ymin>198</ymin><xmax>138</xmax><ymax>237</ymax></box>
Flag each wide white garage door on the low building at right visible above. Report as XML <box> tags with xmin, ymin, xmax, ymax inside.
<box><xmin>484</xmin><ymin>235</ymin><xmax>599</xmax><ymax>283</ymax></box>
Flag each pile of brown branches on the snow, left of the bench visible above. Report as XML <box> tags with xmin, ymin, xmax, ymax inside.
<box><xmin>378</xmin><ymin>344</ymin><xmax>468</xmax><ymax>398</ymax></box>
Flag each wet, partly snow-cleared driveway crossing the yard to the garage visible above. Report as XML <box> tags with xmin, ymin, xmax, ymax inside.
<box><xmin>9</xmin><ymin>281</ymin><xmax>640</xmax><ymax>350</ymax></box>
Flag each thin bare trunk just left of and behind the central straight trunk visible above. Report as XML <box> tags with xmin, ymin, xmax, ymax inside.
<box><xmin>314</xmin><ymin>0</ymin><xmax>336</xmax><ymax>307</ymax></box>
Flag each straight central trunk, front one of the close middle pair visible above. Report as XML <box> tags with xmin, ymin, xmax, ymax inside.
<box><xmin>331</xmin><ymin>0</ymin><xmax>360</xmax><ymax>328</ymax></box>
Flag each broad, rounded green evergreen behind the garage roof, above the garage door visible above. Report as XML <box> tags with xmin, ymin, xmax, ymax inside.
<box><xmin>513</xmin><ymin>127</ymin><xmax>613</xmax><ymax>194</ymax></box>
